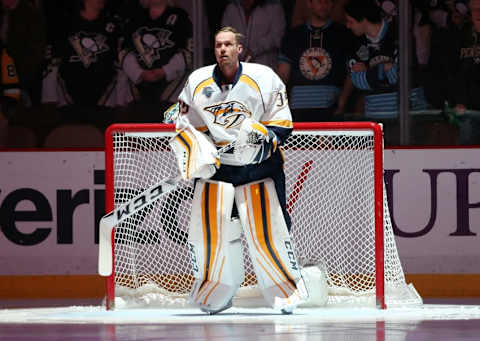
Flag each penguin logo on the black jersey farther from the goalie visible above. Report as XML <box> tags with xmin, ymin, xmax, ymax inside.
<box><xmin>68</xmin><ymin>31</ymin><xmax>110</xmax><ymax>68</ymax></box>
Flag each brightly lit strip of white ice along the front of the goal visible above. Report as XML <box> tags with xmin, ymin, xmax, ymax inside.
<box><xmin>0</xmin><ymin>304</ymin><xmax>480</xmax><ymax>325</ymax></box>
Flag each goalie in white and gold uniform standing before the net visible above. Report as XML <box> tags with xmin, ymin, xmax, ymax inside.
<box><xmin>171</xmin><ymin>27</ymin><xmax>308</xmax><ymax>314</ymax></box>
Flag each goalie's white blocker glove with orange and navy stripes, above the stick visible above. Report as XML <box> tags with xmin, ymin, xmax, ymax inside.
<box><xmin>169</xmin><ymin>119</ymin><xmax>220</xmax><ymax>180</ymax></box>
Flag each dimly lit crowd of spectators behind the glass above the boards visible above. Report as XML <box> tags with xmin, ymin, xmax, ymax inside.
<box><xmin>0</xmin><ymin>0</ymin><xmax>480</xmax><ymax>147</ymax></box>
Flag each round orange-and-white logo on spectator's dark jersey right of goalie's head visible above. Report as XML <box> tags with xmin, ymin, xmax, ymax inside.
<box><xmin>299</xmin><ymin>47</ymin><xmax>332</xmax><ymax>80</ymax></box>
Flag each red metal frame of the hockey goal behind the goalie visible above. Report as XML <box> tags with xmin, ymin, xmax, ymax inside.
<box><xmin>105</xmin><ymin>122</ymin><xmax>387</xmax><ymax>310</ymax></box>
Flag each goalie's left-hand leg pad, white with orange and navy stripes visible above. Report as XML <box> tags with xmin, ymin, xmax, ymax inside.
<box><xmin>188</xmin><ymin>180</ymin><xmax>245</xmax><ymax>314</ymax></box>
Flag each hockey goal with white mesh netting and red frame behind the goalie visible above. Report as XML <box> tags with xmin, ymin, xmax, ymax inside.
<box><xmin>101</xmin><ymin>122</ymin><xmax>422</xmax><ymax>309</ymax></box>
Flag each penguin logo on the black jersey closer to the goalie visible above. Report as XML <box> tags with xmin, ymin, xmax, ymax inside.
<box><xmin>132</xmin><ymin>27</ymin><xmax>175</xmax><ymax>67</ymax></box>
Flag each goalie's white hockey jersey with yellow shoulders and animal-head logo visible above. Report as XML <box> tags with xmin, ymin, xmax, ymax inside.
<box><xmin>177</xmin><ymin>63</ymin><xmax>293</xmax><ymax>146</ymax></box>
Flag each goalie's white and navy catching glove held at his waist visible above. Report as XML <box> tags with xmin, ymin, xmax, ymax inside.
<box><xmin>233</xmin><ymin>118</ymin><xmax>277</xmax><ymax>165</ymax></box>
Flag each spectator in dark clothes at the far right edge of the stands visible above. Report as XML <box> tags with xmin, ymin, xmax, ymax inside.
<box><xmin>449</xmin><ymin>0</ymin><xmax>480</xmax><ymax>144</ymax></box>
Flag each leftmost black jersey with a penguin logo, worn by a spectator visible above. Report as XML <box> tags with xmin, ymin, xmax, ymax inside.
<box><xmin>53</xmin><ymin>15</ymin><xmax>119</xmax><ymax>105</ymax></box>
